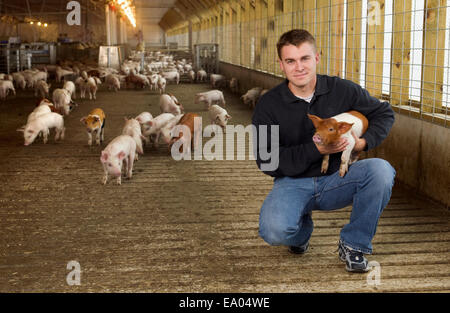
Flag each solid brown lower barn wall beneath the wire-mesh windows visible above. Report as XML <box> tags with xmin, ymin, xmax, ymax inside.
<box><xmin>220</xmin><ymin>62</ymin><xmax>450</xmax><ymax>207</ymax></box>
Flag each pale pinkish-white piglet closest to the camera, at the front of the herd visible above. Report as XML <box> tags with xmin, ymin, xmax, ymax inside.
<box><xmin>100</xmin><ymin>135</ymin><xmax>136</xmax><ymax>185</ymax></box>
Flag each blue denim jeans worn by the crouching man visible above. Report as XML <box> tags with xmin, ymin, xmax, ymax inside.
<box><xmin>259</xmin><ymin>158</ymin><xmax>395</xmax><ymax>254</ymax></box>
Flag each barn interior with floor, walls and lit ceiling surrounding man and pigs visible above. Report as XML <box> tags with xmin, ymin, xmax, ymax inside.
<box><xmin>0</xmin><ymin>0</ymin><xmax>450</xmax><ymax>293</ymax></box>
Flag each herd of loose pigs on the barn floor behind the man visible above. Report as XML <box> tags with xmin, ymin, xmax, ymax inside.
<box><xmin>0</xmin><ymin>52</ymin><xmax>267</xmax><ymax>184</ymax></box>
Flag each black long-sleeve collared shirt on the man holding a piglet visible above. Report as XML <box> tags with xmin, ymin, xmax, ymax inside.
<box><xmin>252</xmin><ymin>75</ymin><xmax>394</xmax><ymax>177</ymax></box>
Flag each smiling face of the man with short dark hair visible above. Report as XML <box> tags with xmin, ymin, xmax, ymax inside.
<box><xmin>279</xmin><ymin>42</ymin><xmax>319</xmax><ymax>88</ymax></box>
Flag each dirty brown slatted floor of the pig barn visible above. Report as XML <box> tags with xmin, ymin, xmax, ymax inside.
<box><xmin>0</xmin><ymin>77</ymin><xmax>450</xmax><ymax>292</ymax></box>
